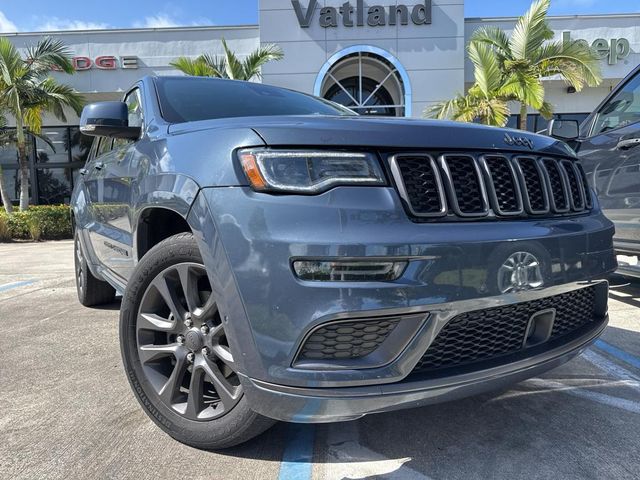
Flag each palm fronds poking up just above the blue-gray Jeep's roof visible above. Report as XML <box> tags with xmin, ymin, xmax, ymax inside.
<box><xmin>171</xmin><ymin>38</ymin><xmax>284</xmax><ymax>80</ymax></box>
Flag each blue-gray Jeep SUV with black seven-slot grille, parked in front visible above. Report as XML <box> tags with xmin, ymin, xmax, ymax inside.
<box><xmin>73</xmin><ymin>77</ymin><xmax>616</xmax><ymax>448</ymax></box>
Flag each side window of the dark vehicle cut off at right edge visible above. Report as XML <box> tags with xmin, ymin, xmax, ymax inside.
<box><xmin>591</xmin><ymin>74</ymin><xmax>640</xmax><ymax>135</ymax></box>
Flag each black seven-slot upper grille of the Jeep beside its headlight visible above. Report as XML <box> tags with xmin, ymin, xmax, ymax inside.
<box><xmin>390</xmin><ymin>153</ymin><xmax>592</xmax><ymax>221</ymax></box>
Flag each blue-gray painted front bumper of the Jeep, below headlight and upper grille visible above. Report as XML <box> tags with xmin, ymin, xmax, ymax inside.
<box><xmin>188</xmin><ymin>187</ymin><xmax>616</xmax><ymax>398</ymax></box>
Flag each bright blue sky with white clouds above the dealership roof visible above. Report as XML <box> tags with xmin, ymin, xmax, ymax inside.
<box><xmin>0</xmin><ymin>0</ymin><xmax>640</xmax><ymax>33</ymax></box>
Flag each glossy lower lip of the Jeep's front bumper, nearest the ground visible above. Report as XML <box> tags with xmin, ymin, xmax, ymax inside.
<box><xmin>241</xmin><ymin>318</ymin><xmax>608</xmax><ymax>423</ymax></box>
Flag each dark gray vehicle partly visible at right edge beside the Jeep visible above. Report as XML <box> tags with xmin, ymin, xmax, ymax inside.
<box><xmin>549</xmin><ymin>62</ymin><xmax>640</xmax><ymax>276</ymax></box>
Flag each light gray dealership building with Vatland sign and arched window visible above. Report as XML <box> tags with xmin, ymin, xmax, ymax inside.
<box><xmin>0</xmin><ymin>0</ymin><xmax>640</xmax><ymax>203</ymax></box>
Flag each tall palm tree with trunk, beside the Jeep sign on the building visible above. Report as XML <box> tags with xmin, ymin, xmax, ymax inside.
<box><xmin>471</xmin><ymin>0</ymin><xmax>602</xmax><ymax>130</ymax></box>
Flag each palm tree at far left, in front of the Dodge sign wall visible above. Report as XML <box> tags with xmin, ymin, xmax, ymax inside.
<box><xmin>0</xmin><ymin>38</ymin><xmax>83</xmax><ymax>210</ymax></box>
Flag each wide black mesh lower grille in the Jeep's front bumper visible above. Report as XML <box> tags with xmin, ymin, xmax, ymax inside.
<box><xmin>413</xmin><ymin>286</ymin><xmax>599</xmax><ymax>373</ymax></box>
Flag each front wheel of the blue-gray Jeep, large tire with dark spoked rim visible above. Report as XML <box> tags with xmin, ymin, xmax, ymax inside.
<box><xmin>120</xmin><ymin>233</ymin><xmax>275</xmax><ymax>450</ymax></box>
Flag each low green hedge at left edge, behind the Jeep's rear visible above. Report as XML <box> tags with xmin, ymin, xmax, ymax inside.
<box><xmin>0</xmin><ymin>205</ymin><xmax>73</xmax><ymax>241</ymax></box>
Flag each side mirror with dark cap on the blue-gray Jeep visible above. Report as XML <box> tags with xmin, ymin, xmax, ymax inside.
<box><xmin>80</xmin><ymin>102</ymin><xmax>141</xmax><ymax>140</ymax></box>
